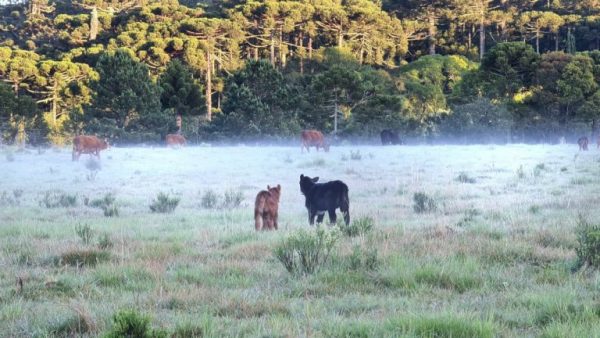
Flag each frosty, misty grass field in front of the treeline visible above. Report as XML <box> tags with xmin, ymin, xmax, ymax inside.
<box><xmin>0</xmin><ymin>145</ymin><xmax>600</xmax><ymax>337</ymax></box>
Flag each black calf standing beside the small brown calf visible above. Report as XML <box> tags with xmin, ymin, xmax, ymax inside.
<box><xmin>300</xmin><ymin>175</ymin><xmax>350</xmax><ymax>225</ymax></box>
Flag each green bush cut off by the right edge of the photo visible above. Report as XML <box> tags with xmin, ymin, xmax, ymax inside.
<box><xmin>575</xmin><ymin>219</ymin><xmax>600</xmax><ymax>268</ymax></box>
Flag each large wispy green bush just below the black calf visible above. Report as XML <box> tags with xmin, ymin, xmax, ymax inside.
<box><xmin>273</xmin><ymin>227</ymin><xmax>339</xmax><ymax>274</ymax></box>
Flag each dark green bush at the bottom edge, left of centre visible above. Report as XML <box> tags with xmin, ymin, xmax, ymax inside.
<box><xmin>104</xmin><ymin>310</ymin><xmax>167</xmax><ymax>338</ymax></box>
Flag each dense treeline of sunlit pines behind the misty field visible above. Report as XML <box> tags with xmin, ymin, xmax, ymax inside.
<box><xmin>0</xmin><ymin>0</ymin><xmax>600</xmax><ymax>144</ymax></box>
